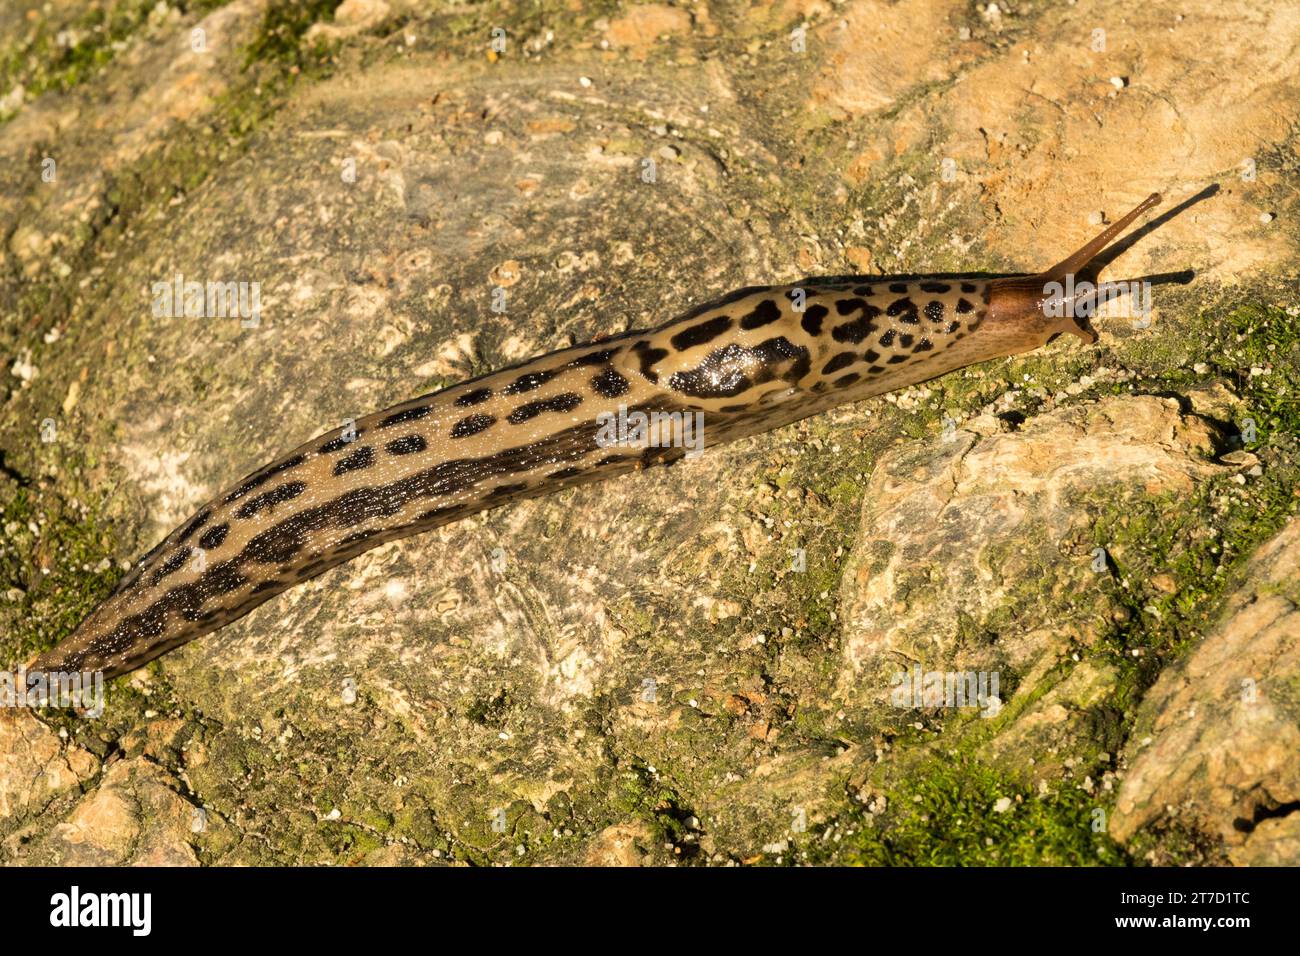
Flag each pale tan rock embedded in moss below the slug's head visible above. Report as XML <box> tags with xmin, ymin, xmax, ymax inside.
<box><xmin>840</xmin><ymin>395</ymin><xmax>1223</xmax><ymax>702</ymax></box>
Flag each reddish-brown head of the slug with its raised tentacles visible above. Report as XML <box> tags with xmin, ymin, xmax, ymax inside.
<box><xmin>980</xmin><ymin>193</ymin><xmax>1160</xmax><ymax>355</ymax></box>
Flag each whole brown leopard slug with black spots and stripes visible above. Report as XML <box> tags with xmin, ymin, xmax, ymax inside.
<box><xmin>30</xmin><ymin>195</ymin><xmax>1160</xmax><ymax>679</ymax></box>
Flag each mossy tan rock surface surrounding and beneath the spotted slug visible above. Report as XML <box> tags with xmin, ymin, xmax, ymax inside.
<box><xmin>0</xmin><ymin>0</ymin><xmax>1300</xmax><ymax>865</ymax></box>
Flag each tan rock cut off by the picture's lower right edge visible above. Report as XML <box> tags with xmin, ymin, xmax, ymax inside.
<box><xmin>1110</xmin><ymin>520</ymin><xmax>1300</xmax><ymax>865</ymax></box>
